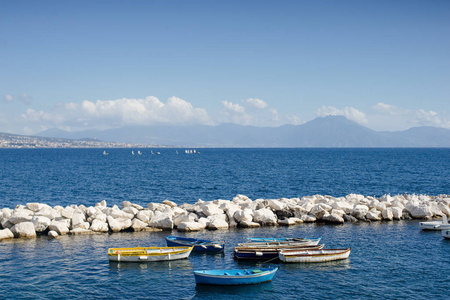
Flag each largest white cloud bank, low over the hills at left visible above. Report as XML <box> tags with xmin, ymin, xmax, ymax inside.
<box><xmin>22</xmin><ymin>96</ymin><xmax>212</xmax><ymax>130</ymax></box>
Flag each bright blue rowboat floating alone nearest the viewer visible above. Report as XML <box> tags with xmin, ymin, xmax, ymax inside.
<box><xmin>194</xmin><ymin>268</ymin><xmax>278</xmax><ymax>285</ymax></box>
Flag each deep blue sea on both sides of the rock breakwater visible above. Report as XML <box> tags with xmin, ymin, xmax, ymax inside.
<box><xmin>0</xmin><ymin>148</ymin><xmax>450</xmax><ymax>299</ymax></box>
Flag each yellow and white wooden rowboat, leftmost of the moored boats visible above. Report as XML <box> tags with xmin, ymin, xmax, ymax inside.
<box><xmin>108</xmin><ymin>246</ymin><xmax>193</xmax><ymax>262</ymax></box>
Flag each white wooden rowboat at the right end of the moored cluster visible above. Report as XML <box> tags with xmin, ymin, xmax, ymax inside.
<box><xmin>278</xmin><ymin>248</ymin><xmax>352</xmax><ymax>263</ymax></box>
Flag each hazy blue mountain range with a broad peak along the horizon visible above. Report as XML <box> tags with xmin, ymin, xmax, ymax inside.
<box><xmin>37</xmin><ymin>116</ymin><xmax>450</xmax><ymax>148</ymax></box>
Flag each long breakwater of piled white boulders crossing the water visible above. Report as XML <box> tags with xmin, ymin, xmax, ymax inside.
<box><xmin>0</xmin><ymin>194</ymin><xmax>450</xmax><ymax>240</ymax></box>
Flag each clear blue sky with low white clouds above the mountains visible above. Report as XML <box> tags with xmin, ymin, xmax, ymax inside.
<box><xmin>0</xmin><ymin>0</ymin><xmax>450</xmax><ymax>134</ymax></box>
